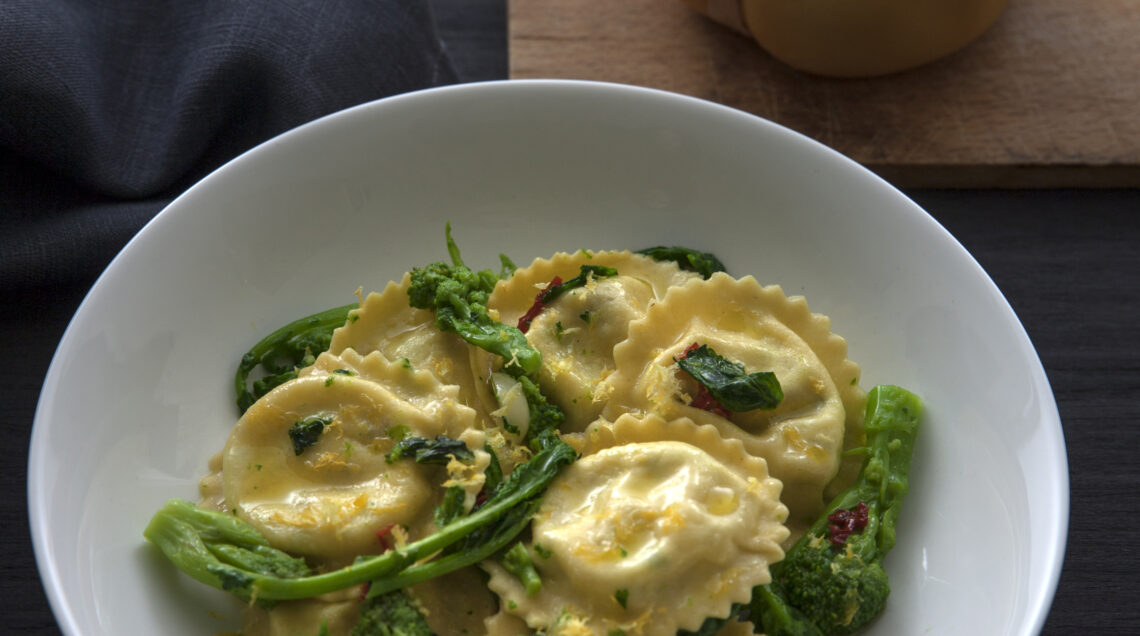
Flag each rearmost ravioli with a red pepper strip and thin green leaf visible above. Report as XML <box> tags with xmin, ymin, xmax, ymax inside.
<box><xmin>475</xmin><ymin>250</ymin><xmax>698</xmax><ymax>432</ymax></box>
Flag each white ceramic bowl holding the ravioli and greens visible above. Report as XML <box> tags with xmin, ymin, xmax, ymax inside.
<box><xmin>29</xmin><ymin>81</ymin><xmax>1068</xmax><ymax>636</ymax></box>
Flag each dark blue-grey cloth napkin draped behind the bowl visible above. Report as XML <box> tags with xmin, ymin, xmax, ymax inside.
<box><xmin>0</xmin><ymin>0</ymin><xmax>455</xmax><ymax>292</ymax></box>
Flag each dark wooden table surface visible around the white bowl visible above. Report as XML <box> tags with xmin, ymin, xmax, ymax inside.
<box><xmin>0</xmin><ymin>0</ymin><xmax>1140</xmax><ymax>635</ymax></box>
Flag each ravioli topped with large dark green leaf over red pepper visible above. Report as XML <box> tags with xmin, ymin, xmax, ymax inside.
<box><xmin>603</xmin><ymin>274</ymin><xmax>865</xmax><ymax>531</ymax></box>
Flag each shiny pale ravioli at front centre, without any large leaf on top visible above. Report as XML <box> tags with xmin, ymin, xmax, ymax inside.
<box><xmin>485</xmin><ymin>415</ymin><xmax>788</xmax><ymax>636</ymax></box>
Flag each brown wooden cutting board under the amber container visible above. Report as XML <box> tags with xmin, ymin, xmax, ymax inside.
<box><xmin>508</xmin><ymin>0</ymin><xmax>1140</xmax><ymax>188</ymax></box>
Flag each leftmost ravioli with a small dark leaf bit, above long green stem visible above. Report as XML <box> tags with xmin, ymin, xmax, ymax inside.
<box><xmin>221</xmin><ymin>373</ymin><xmax>474</xmax><ymax>565</ymax></box>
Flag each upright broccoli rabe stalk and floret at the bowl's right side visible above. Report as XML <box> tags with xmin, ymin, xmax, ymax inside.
<box><xmin>750</xmin><ymin>385</ymin><xmax>922</xmax><ymax>636</ymax></box>
